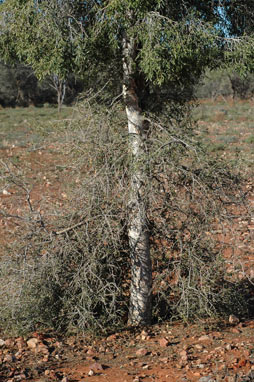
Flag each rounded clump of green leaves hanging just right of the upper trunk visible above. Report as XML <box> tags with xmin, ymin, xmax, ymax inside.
<box><xmin>139</xmin><ymin>14</ymin><xmax>218</xmax><ymax>85</ymax></box>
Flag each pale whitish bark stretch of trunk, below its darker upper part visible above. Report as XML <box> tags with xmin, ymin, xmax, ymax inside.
<box><xmin>126</xmin><ymin>92</ymin><xmax>152</xmax><ymax>325</ymax></box>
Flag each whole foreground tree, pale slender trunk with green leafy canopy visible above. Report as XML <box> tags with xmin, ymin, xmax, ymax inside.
<box><xmin>1</xmin><ymin>0</ymin><xmax>222</xmax><ymax>325</ymax></box>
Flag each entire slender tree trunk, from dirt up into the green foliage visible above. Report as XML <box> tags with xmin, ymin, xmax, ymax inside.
<box><xmin>123</xmin><ymin>37</ymin><xmax>152</xmax><ymax>325</ymax></box>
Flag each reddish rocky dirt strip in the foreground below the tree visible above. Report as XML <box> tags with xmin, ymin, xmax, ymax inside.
<box><xmin>0</xmin><ymin>317</ymin><xmax>254</xmax><ymax>382</ymax></box>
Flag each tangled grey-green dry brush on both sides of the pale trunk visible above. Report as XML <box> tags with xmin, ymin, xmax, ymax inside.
<box><xmin>0</xmin><ymin>101</ymin><xmax>251</xmax><ymax>332</ymax></box>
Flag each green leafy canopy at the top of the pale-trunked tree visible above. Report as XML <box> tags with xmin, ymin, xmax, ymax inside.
<box><xmin>0</xmin><ymin>0</ymin><xmax>222</xmax><ymax>85</ymax></box>
